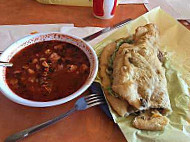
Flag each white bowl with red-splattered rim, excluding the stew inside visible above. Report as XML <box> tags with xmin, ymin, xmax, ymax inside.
<box><xmin>0</xmin><ymin>32</ymin><xmax>98</xmax><ymax>107</ymax></box>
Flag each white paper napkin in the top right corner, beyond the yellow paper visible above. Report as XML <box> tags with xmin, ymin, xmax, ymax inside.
<box><xmin>145</xmin><ymin>0</ymin><xmax>190</xmax><ymax>20</ymax></box>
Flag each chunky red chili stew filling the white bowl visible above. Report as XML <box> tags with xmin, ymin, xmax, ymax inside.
<box><xmin>6</xmin><ymin>41</ymin><xmax>90</xmax><ymax>101</ymax></box>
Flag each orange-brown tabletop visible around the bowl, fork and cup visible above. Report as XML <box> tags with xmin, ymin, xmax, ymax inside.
<box><xmin>0</xmin><ymin>0</ymin><xmax>190</xmax><ymax>142</ymax></box>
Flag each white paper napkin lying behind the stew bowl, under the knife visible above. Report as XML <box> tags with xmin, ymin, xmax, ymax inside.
<box><xmin>0</xmin><ymin>24</ymin><xmax>111</xmax><ymax>51</ymax></box>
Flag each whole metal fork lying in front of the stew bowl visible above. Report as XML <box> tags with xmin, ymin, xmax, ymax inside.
<box><xmin>5</xmin><ymin>94</ymin><xmax>106</xmax><ymax>142</ymax></box>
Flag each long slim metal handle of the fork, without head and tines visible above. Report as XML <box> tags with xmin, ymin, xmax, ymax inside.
<box><xmin>4</xmin><ymin>107</ymin><xmax>76</xmax><ymax>142</ymax></box>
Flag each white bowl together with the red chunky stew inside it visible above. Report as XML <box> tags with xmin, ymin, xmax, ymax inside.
<box><xmin>0</xmin><ymin>33</ymin><xmax>98</xmax><ymax>107</ymax></box>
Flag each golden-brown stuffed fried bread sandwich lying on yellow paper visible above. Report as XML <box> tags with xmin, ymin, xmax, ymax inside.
<box><xmin>100</xmin><ymin>24</ymin><xmax>172</xmax><ymax>130</ymax></box>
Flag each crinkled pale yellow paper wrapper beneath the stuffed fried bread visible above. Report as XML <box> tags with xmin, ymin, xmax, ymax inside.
<box><xmin>94</xmin><ymin>7</ymin><xmax>190</xmax><ymax>142</ymax></box>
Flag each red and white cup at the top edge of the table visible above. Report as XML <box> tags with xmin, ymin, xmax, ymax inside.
<box><xmin>93</xmin><ymin>0</ymin><xmax>117</xmax><ymax>19</ymax></box>
